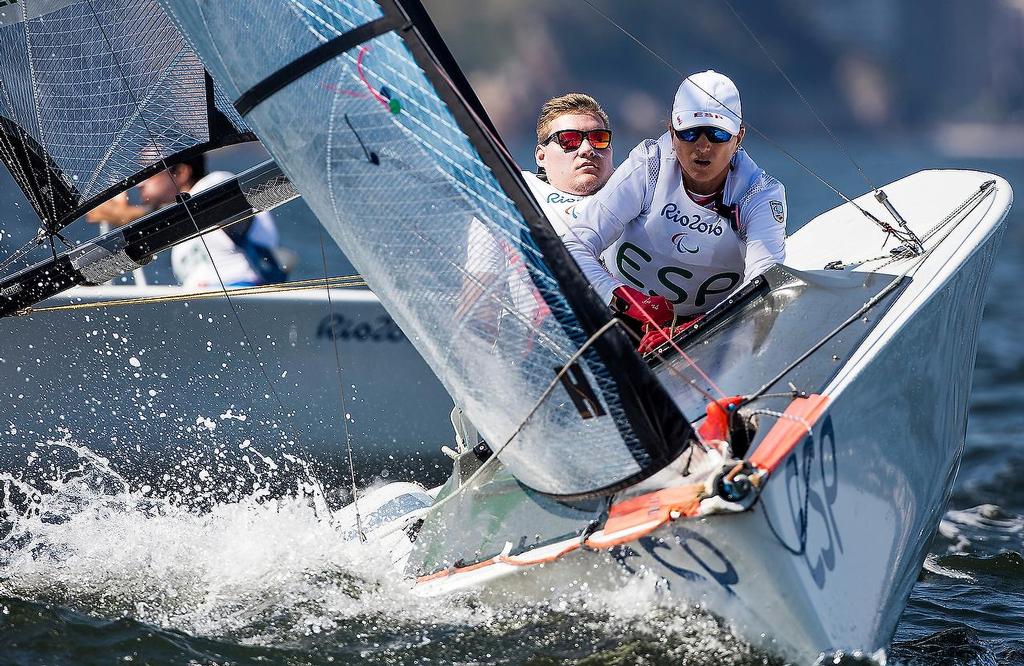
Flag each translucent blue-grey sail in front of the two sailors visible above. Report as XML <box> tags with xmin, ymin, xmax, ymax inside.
<box><xmin>163</xmin><ymin>0</ymin><xmax>692</xmax><ymax>497</ymax></box>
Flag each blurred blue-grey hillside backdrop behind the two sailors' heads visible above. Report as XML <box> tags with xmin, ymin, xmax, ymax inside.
<box><xmin>425</xmin><ymin>0</ymin><xmax>1024</xmax><ymax>155</ymax></box>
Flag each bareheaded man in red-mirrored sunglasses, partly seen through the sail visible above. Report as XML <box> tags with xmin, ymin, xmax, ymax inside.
<box><xmin>461</xmin><ymin>92</ymin><xmax>613</xmax><ymax>329</ymax></box>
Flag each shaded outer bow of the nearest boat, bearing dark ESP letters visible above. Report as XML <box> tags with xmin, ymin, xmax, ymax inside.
<box><xmin>610</xmin><ymin>226</ymin><xmax>997</xmax><ymax>661</ymax></box>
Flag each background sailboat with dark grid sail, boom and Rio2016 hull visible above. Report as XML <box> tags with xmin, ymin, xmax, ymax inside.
<box><xmin>0</xmin><ymin>1</ymin><xmax>451</xmax><ymax>475</ymax></box>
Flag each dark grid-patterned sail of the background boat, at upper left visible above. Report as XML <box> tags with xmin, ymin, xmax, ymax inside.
<box><xmin>0</xmin><ymin>0</ymin><xmax>255</xmax><ymax>233</ymax></box>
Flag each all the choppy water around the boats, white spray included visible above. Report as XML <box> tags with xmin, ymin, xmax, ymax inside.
<box><xmin>0</xmin><ymin>143</ymin><xmax>1024</xmax><ymax>665</ymax></box>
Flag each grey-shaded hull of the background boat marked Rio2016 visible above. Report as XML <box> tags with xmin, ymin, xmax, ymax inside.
<box><xmin>0</xmin><ymin>286</ymin><xmax>452</xmax><ymax>481</ymax></box>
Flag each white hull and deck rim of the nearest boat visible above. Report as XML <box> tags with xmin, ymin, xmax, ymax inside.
<box><xmin>409</xmin><ymin>172</ymin><xmax>1012</xmax><ymax>663</ymax></box>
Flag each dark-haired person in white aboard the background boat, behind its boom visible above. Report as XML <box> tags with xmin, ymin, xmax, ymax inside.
<box><xmin>86</xmin><ymin>155</ymin><xmax>288</xmax><ymax>288</ymax></box>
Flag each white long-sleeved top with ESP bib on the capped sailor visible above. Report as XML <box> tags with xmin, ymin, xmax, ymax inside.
<box><xmin>563</xmin><ymin>132</ymin><xmax>786</xmax><ymax>315</ymax></box>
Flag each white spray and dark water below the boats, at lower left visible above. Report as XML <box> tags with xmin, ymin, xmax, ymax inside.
<box><xmin>0</xmin><ymin>442</ymin><xmax>778</xmax><ymax>664</ymax></box>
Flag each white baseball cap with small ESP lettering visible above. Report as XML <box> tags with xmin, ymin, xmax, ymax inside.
<box><xmin>672</xmin><ymin>70</ymin><xmax>742</xmax><ymax>134</ymax></box>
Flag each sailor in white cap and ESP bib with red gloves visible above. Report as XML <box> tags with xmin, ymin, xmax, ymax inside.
<box><xmin>563</xmin><ymin>70</ymin><xmax>786</xmax><ymax>351</ymax></box>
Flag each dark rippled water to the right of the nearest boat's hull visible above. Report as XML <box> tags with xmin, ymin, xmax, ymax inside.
<box><xmin>891</xmin><ymin>214</ymin><xmax>1024</xmax><ymax>664</ymax></box>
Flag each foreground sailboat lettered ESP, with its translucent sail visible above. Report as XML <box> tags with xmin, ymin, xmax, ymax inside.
<box><xmin>0</xmin><ymin>0</ymin><xmax>1012</xmax><ymax>661</ymax></box>
